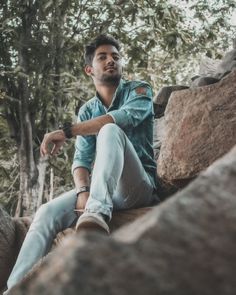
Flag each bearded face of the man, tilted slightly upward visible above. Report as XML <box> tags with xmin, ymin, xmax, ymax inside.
<box><xmin>86</xmin><ymin>45</ymin><xmax>122</xmax><ymax>85</ymax></box>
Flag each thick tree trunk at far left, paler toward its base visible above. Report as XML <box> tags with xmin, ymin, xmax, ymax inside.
<box><xmin>15</xmin><ymin>6</ymin><xmax>41</xmax><ymax>217</ymax></box>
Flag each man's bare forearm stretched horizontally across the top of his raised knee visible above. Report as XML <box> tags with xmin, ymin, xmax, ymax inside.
<box><xmin>71</xmin><ymin>115</ymin><xmax>114</xmax><ymax>136</ymax></box>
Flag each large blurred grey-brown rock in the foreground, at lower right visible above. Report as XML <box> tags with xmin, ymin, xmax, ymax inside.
<box><xmin>10</xmin><ymin>147</ymin><xmax>236</xmax><ymax>295</ymax></box>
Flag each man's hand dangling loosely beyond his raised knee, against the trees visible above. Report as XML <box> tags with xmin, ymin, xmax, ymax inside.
<box><xmin>40</xmin><ymin>130</ymin><xmax>66</xmax><ymax>156</ymax></box>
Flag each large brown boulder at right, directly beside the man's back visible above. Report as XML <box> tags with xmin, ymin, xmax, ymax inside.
<box><xmin>158</xmin><ymin>72</ymin><xmax>236</xmax><ymax>184</ymax></box>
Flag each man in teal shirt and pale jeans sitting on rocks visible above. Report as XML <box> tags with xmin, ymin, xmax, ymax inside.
<box><xmin>5</xmin><ymin>35</ymin><xmax>159</xmax><ymax>294</ymax></box>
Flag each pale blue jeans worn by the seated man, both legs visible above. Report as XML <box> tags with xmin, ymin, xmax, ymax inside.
<box><xmin>7</xmin><ymin>124</ymin><xmax>155</xmax><ymax>289</ymax></box>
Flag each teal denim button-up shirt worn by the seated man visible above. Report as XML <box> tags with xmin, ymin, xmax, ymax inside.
<box><xmin>72</xmin><ymin>80</ymin><xmax>156</xmax><ymax>188</ymax></box>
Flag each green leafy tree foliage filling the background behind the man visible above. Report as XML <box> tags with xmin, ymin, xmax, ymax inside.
<box><xmin>0</xmin><ymin>0</ymin><xmax>236</xmax><ymax>213</ymax></box>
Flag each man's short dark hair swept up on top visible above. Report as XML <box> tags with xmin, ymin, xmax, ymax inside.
<box><xmin>84</xmin><ymin>34</ymin><xmax>120</xmax><ymax>66</ymax></box>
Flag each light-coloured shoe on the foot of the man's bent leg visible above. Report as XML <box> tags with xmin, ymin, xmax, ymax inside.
<box><xmin>75</xmin><ymin>212</ymin><xmax>110</xmax><ymax>235</ymax></box>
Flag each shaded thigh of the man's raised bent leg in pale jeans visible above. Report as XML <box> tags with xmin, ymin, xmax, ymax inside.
<box><xmin>112</xmin><ymin>138</ymin><xmax>153</xmax><ymax>210</ymax></box>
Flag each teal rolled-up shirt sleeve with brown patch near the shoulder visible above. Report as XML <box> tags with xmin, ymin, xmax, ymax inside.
<box><xmin>107</xmin><ymin>84</ymin><xmax>153</xmax><ymax>129</ymax></box>
